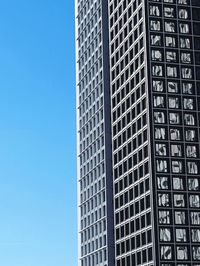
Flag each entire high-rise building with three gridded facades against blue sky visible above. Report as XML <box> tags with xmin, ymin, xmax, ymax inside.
<box><xmin>76</xmin><ymin>0</ymin><xmax>200</xmax><ymax>266</ymax></box>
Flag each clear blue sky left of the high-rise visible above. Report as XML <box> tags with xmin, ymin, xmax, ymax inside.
<box><xmin>0</xmin><ymin>0</ymin><xmax>77</xmax><ymax>266</ymax></box>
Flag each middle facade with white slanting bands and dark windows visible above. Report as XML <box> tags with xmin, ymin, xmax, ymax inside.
<box><xmin>109</xmin><ymin>0</ymin><xmax>153</xmax><ymax>266</ymax></box>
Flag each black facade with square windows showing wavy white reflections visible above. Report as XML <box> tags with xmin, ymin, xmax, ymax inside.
<box><xmin>145</xmin><ymin>0</ymin><xmax>200</xmax><ymax>266</ymax></box>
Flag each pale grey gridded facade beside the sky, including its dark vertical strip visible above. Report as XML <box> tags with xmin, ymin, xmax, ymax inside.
<box><xmin>76</xmin><ymin>0</ymin><xmax>114</xmax><ymax>266</ymax></box>
